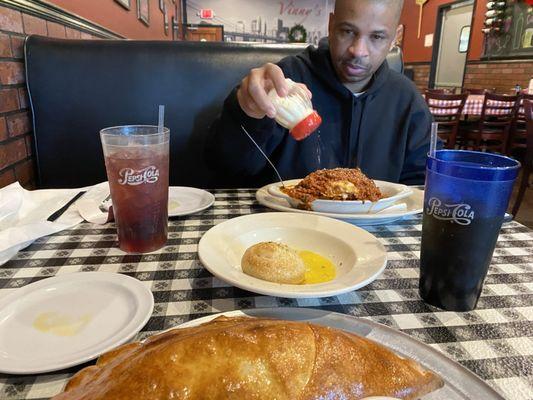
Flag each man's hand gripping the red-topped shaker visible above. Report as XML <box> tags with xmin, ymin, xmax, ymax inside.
<box><xmin>237</xmin><ymin>63</ymin><xmax>311</xmax><ymax>119</ymax></box>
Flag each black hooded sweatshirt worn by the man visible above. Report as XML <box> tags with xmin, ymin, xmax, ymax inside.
<box><xmin>206</xmin><ymin>45</ymin><xmax>432</xmax><ymax>187</ymax></box>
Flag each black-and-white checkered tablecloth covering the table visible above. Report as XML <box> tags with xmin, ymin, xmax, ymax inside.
<box><xmin>0</xmin><ymin>190</ymin><xmax>533</xmax><ymax>400</ymax></box>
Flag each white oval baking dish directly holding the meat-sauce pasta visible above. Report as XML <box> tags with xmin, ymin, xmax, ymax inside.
<box><xmin>267</xmin><ymin>179</ymin><xmax>413</xmax><ymax>214</ymax></box>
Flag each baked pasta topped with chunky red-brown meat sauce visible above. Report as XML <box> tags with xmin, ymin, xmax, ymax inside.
<box><xmin>281</xmin><ymin>168</ymin><xmax>383</xmax><ymax>207</ymax></box>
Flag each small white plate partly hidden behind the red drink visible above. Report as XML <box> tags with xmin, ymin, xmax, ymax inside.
<box><xmin>168</xmin><ymin>186</ymin><xmax>215</xmax><ymax>217</ymax></box>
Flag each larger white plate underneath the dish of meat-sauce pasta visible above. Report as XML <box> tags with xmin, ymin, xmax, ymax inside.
<box><xmin>255</xmin><ymin>181</ymin><xmax>424</xmax><ymax>226</ymax></box>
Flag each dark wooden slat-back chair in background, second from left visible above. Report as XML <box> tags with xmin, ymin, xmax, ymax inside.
<box><xmin>461</xmin><ymin>93</ymin><xmax>518</xmax><ymax>154</ymax></box>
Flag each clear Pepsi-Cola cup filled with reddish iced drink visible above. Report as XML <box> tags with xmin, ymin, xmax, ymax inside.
<box><xmin>100</xmin><ymin>125</ymin><xmax>170</xmax><ymax>253</ymax></box>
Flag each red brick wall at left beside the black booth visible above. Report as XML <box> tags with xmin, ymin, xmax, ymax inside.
<box><xmin>0</xmin><ymin>6</ymin><xmax>100</xmax><ymax>188</ymax></box>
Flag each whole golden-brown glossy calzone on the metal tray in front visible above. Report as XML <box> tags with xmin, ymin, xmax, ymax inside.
<box><xmin>55</xmin><ymin>317</ymin><xmax>442</xmax><ymax>400</ymax></box>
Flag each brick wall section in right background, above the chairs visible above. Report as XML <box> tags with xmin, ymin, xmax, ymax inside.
<box><xmin>464</xmin><ymin>60</ymin><xmax>533</xmax><ymax>93</ymax></box>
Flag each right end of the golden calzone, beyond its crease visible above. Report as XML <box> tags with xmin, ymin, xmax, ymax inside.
<box><xmin>303</xmin><ymin>325</ymin><xmax>443</xmax><ymax>399</ymax></box>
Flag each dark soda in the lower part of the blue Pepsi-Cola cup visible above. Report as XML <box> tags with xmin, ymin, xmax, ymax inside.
<box><xmin>419</xmin><ymin>214</ymin><xmax>503</xmax><ymax>311</ymax></box>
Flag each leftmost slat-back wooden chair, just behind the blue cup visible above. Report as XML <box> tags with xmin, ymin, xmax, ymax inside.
<box><xmin>425</xmin><ymin>90</ymin><xmax>467</xmax><ymax>149</ymax></box>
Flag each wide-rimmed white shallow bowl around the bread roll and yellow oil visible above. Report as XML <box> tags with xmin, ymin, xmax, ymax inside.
<box><xmin>198</xmin><ymin>212</ymin><xmax>387</xmax><ymax>298</ymax></box>
